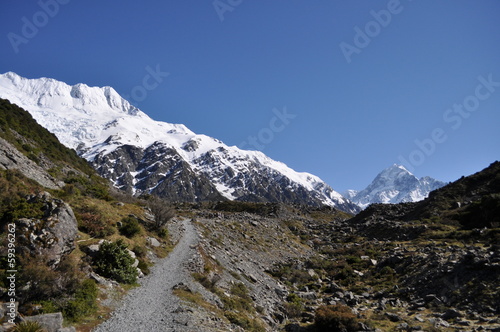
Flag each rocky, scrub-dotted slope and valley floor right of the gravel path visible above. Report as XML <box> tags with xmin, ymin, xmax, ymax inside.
<box><xmin>169</xmin><ymin>162</ymin><xmax>500</xmax><ymax>332</ymax></box>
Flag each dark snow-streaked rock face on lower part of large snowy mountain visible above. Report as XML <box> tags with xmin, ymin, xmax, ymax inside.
<box><xmin>92</xmin><ymin>142</ymin><xmax>359</xmax><ymax>212</ymax></box>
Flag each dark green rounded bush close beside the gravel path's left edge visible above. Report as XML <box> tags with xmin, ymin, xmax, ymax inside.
<box><xmin>94</xmin><ymin>240</ymin><xmax>137</xmax><ymax>284</ymax></box>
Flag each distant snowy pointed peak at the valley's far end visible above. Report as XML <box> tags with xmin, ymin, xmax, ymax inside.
<box><xmin>344</xmin><ymin>164</ymin><xmax>446</xmax><ymax>209</ymax></box>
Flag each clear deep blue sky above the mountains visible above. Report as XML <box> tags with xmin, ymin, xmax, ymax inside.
<box><xmin>0</xmin><ymin>0</ymin><xmax>500</xmax><ymax>191</ymax></box>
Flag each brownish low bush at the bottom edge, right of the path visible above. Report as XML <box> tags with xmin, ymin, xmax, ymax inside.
<box><xmin>314</xmin><ymin>304</ymin><xmax>359</xmax><ymax>332</ymax></box>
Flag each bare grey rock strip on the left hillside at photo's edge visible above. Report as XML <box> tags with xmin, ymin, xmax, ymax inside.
<box><xmin>0</xmin><ymin>138</ymin><xmax>64</xmax><ymax>189</ymax></box>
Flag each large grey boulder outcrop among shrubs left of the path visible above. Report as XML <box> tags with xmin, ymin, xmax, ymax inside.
<box><xmin>16</xmin><ymin>192</ymin><xmax>78</xmax><ymax>266</ymax></box>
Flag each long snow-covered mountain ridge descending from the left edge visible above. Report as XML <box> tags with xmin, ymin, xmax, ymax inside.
<box><xmin>0</xmin><ymin>72</ymin><xmax>359</xmax><ymax>212</ymax></box>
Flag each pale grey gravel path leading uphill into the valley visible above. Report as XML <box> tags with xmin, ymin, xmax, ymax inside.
<box><xmin>94</xmin><ymin>219</ymin><xmax>198</xmax><ymax>332</ymax></box>
